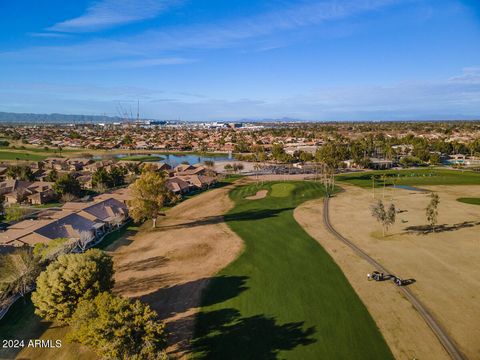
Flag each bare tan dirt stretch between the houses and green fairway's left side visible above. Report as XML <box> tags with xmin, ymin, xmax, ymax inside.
<box><xmin>107</xmin><ymin>187</ymin><xmax>243</xmax><ymax>358</ymax></box>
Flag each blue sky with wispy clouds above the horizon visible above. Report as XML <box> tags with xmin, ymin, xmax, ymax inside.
<box><xmin>0</xmin><ymin>0</ymin><xmax>480</xmax><ymax>121</ymax></box>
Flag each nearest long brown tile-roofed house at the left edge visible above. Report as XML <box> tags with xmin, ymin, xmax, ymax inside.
<box><xmin>0</xmin><ymin>198</ymin><xmax>128</xmax><ymax>246</ymax></box>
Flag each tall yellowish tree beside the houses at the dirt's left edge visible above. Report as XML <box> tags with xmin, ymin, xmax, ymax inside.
<box><xmin>129</xmin><ymin>171</ymin><xmax>178</xmax><ymax>228</ymax></box>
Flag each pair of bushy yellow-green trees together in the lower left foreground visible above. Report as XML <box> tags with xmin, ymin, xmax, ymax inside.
<box><xmin>27</xmin><ymin>249</ymin><xmax>166</xmax><ymax>360</ymax></box>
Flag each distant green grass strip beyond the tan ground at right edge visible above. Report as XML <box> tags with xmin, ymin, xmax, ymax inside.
<box><xmin>336</xmin><ymin>169</ymin><xmax>480</xmax><ymax>187</ymax></box>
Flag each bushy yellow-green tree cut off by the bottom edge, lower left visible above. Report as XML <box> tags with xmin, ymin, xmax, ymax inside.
<box><xmin>68</xmin><ymin>292</ymin><xmax>166</xmax><ymax>360</ymax></box>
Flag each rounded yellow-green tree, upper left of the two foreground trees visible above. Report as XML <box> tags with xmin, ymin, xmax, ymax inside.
<box><xmin>32</xmin><ymin>249</ymin><xmax>113</xmax><ymax>322</ymax></box>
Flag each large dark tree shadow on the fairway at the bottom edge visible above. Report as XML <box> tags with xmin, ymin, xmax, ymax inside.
<box><xmin>192</xmin><ymin>309</ymin><xmax>316</xmax><ymax>360</ymax></box>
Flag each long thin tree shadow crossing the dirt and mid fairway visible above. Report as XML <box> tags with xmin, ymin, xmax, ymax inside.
<box><xmin>154</xmin><ymin>207</ymin><xmax>294</xmax><ymax>231</ymax></box>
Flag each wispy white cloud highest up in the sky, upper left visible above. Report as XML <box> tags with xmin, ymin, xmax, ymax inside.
<box><xmin>47</xmin><ymin>0</ymin><xmax>180</xmax><ymax>33</ymax></box>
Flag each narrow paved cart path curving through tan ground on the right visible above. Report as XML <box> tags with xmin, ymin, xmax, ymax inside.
<box><xmin>323</xmin><ymin>197</ymin><xmax>467</xmax><ymax>360</ymax></box>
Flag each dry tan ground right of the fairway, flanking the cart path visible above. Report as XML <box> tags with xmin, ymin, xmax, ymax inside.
<box><xmin>300</xmin><ymin>185</ymin><xmax>480</xmax><ymax>359</ymax></box>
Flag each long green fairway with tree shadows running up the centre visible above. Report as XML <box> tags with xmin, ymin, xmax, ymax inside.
<box><xmin>192</xmin><ymin>182</ymin><xmax>393</xmax><ymax>360</ymax></box>
